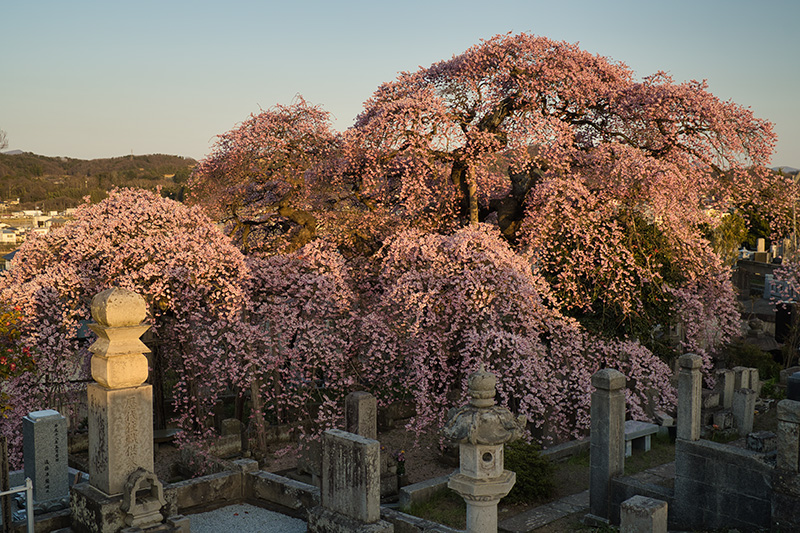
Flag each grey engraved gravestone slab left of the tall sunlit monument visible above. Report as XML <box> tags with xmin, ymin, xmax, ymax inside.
<box><xmin>22</xmin><ymin>409</ymin><xmax>69</xmax><ymax>503</ymax></box>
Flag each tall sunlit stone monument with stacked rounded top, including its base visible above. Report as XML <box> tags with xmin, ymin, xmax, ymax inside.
<box><xmin>70</xmin><ymin>288</ymin><xmax>177</xmax><ymax>533</ymax></box>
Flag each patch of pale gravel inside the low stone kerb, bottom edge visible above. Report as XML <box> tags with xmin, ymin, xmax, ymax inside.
<box><xmin>189</xmin><ymin>503</ymin><xmax>306</xmax><ymax>533</ymax></box>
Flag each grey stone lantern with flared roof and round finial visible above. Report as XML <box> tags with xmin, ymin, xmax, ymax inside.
<box><xmin>442</xmin><ymin>366</ymin><xmax>525</xmax><ymax>533</ymax></box>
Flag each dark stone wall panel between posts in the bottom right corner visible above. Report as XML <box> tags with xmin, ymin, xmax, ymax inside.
<box><xmin>670</xmin><ymin>439</ymin><xmax>774</xmax><ymax>529</ymax></box>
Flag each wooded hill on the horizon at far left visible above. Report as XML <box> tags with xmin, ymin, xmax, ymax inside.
<box><xmin>0</xmin><ymin>152</ymin><xmax>197</xmax><ymax>211</ymax></box>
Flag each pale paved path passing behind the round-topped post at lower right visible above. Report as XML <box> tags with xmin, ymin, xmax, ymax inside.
<box><xmin>498</xmin><ymin>462</ymin><xmax>675</xmax><ymax>533</ymax></box>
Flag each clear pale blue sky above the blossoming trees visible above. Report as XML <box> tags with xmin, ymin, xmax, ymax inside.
<box><xmin>0</xmin><ymin>0</ymin><xmax>800</xmax><ymax>167</ymax></box>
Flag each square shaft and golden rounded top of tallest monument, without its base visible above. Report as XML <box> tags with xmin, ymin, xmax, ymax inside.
<box><xmin>87</xmin><ymin>288</ymin><xmax>153</xmax><ymax>496</ymax></box>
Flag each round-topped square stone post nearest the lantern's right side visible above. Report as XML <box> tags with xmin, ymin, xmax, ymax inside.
<box><xmin>587</xmin><ymin>368</ymin><xmax>625</xmax><ymax>522</ymax></box>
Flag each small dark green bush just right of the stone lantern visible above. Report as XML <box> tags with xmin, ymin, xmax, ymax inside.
<box><xmin>505</xmin><ymin>440</ymin><xmax>555</xmax><ymax>503</ymax></box>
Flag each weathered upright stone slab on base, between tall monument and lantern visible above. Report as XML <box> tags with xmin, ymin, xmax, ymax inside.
<box><xmin>308</xmin><ymin>429</ymin><xmax>394</xmax><ymax>533</ymax></box>
